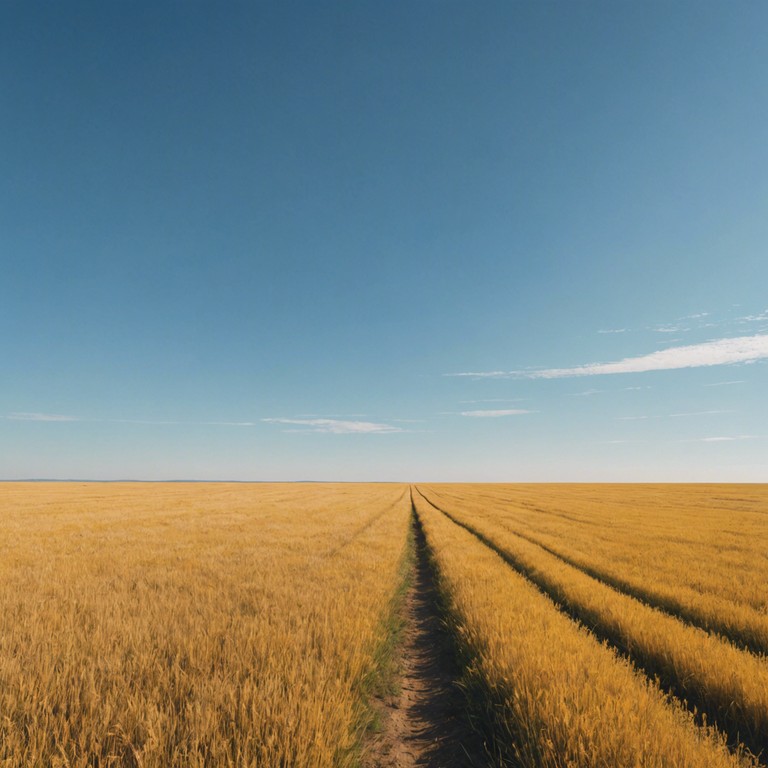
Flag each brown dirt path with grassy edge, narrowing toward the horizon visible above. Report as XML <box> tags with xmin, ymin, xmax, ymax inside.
<box><xmin>363</xmin><ymin>510</ymin><xmax>489</xmax><ymax>768</ymax></box>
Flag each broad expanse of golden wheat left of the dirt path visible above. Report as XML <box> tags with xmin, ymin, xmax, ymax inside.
<box><xmin>0</xmin><ymin>484</ymin><xmax>410</xmax><ymax>768</ymax></box>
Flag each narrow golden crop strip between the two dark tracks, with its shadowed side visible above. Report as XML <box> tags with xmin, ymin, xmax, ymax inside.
<box><xmin>421</xmin><ymin>488</ymin><xmax>768</xmax><ymax>753</ymax></box>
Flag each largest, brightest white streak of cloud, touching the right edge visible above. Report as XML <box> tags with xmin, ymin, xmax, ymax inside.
<box><xmin>446</xmin><ymin>334</ymin><xmax>768</xmax><ymax>379</ymax></box>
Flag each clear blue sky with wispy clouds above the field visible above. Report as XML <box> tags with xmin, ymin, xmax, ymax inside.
<box><xmin>0</xmin><ymin>0</ymin><xmax>768</xmax><ymax>481</ymax></box>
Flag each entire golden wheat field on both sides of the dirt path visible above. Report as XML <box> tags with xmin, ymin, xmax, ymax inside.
<box><xmin>0</xmin><ymin>483</ymin><xmax>768</xmax><ymax>768</ymax></box>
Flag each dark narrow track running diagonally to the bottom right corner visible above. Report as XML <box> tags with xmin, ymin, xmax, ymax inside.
<box><xmin>415</xmin><ymin>487</ymin><xmax>768</xmax><ymax>766</ymax></box>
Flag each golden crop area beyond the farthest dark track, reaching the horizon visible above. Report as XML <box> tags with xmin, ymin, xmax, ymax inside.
<box><xmin>430</xmin><ymin>486</ymin><xmax>768</xmax><ymax>653</ymax></box>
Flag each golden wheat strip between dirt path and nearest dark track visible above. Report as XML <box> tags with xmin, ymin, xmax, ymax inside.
<box><xmin>414</xmin><ymin>493</ymin><xmax>743</xmax><ymax>768</ymax></box>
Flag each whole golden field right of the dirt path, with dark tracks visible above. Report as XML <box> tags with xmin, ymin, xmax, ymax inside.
<box><xmin>414</xmin><ymin>485</ymin><xmax>768</xmax><ymax>768</ymax></box>
